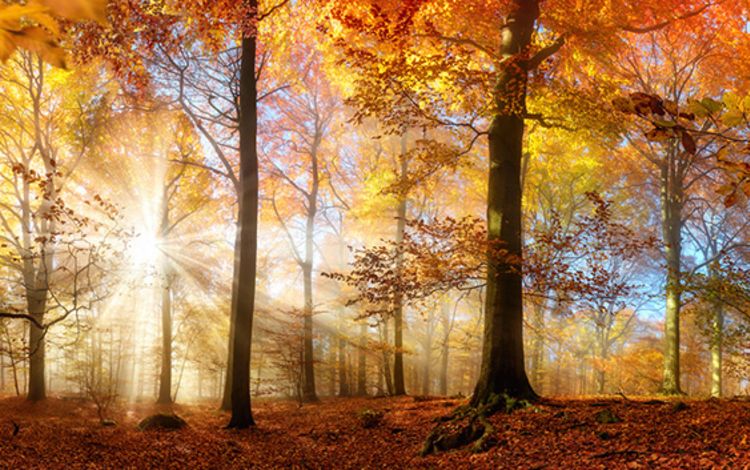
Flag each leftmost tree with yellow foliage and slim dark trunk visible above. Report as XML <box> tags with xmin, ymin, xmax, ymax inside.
<box><xmin>0</xmin><ymin>53</ymin><xmax>122</xmax><ymax>401</ymax></box>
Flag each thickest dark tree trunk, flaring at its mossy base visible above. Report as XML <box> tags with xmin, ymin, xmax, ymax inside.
<box><xmin>471</xmin><ymin>0</ymin><xmax>539</xmax><ymax>406</ymax></box>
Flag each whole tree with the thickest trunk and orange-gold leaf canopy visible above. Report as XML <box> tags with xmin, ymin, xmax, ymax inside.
<box><xmin>331</xmin><ymin>0</ymin><xmax>724</xmax><ymax>412</ymax></box>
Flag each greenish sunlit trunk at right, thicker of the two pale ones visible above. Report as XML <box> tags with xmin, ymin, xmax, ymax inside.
<box><xmin>660</xmin><ymin>157</ymin><xmax>682</xmax><ymax>395</ymax></box>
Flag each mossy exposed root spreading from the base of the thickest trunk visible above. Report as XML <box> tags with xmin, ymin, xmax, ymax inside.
<box><xmin>420</xmin><ymin>395</ymin><xmax>529</xmax><ymax>457</ymax></box>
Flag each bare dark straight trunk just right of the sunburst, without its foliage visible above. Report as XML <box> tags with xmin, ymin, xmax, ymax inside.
<box><xmin>228</xmin><ymin>20</ymin><xmax>258</xmax><ymax>428</ymax></box>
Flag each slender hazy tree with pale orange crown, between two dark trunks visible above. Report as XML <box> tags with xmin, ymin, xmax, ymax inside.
<box><xmin>266</xmin><ymin>56</ymin><xmax>339</xmax><ymax>402</ymax></box>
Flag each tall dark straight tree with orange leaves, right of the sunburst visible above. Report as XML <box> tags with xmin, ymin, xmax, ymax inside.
<box><xmin>78</xmin><ymin>0</ymin><xmax>296</xmax><ymax>428</ymax></box>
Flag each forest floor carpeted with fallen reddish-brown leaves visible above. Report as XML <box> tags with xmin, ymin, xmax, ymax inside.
<box><xmin>0</xmin><ymin>397</ymin><xmax>750</xmax><ymax>469</ymax></box>
